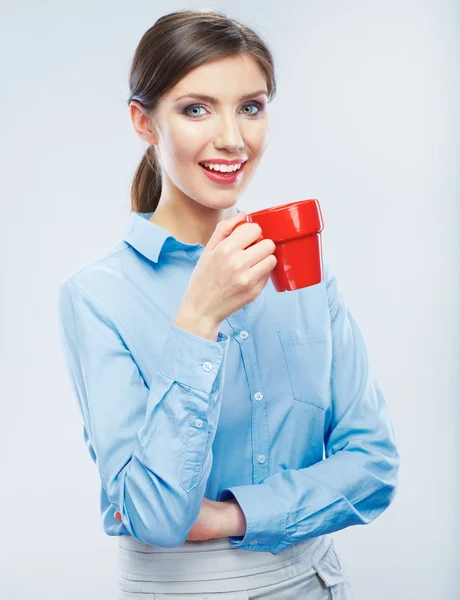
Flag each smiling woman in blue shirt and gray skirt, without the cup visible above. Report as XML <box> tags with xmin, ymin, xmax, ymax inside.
<box><xmin>59</xmin><ymin>10</ymin><xmax>399</xmax><ymax>600</ymax></box>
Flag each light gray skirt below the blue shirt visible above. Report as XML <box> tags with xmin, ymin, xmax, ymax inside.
<box><xmin>117</xmin><ymin>535</ymin><xmax>354</xmax><ymax>600</ymax></box>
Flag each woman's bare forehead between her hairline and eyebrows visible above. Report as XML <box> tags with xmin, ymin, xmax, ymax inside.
<box><xmin>164</xmin><ymin>54</ymin><xmax>267</xmax><ymax>101</ymax></box>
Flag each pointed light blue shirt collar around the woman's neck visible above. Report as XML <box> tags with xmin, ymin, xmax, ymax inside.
<box><xmin>123</xmin><ymin>208</ymin><xmax>241</xmax><ymax>262</ymax></box>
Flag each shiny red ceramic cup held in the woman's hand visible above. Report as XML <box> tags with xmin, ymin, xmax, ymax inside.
<box><xmin>235</xmin><ymin>199</ymin><xmax>324</xmax><ymax>292</ymax></box>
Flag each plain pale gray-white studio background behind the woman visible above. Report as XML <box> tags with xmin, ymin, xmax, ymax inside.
<box><xmin>0</xmin><ymin>0</ymin><xmax>460</xmax><ymax>600</ymax></box>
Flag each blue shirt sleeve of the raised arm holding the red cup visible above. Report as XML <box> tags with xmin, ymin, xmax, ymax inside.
<box><xmin>58</xmin><ymin>279</ymin><xmax>229</xmax><ymax>547</ymax></box>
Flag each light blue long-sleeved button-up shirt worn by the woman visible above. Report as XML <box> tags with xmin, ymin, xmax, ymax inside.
<box><xmin>58</xmin><ymin>211</ymin><xmax>399</xmax><ymax>554</ymax></box>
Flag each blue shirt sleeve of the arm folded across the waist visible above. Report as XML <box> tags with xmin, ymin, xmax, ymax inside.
<box><xmin>219</xmin><ymin>265</ymin><xmax>399</xmax><ymax>554</ymax></box>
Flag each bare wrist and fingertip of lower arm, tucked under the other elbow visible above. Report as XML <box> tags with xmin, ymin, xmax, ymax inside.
<box><xmin>115</xmin><ymin>498</ymin><xmax>246</xmax><ymax>542</ymax></box>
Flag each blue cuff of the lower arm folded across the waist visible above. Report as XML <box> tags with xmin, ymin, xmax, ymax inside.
<box><xmin>219</xmin><ymin>483</ymin><xmax>290</xmax><ymax>554</ymax></box>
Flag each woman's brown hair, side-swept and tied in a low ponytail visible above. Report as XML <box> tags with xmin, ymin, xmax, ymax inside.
<box><xmin>128</xmin><ymin>9</ymin><xmax>276</xmax><ymax>212</ymax></box>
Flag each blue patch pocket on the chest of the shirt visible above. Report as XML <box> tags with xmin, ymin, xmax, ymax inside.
<box><xmin>277</xmin><ymin>327</ymin><xmax>332</xmax><ymax>410</ymax></box>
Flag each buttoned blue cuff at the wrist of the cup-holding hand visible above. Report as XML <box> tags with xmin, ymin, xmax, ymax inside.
<box><xmin>159</xmin><ymin>321</ymin><xmax>230</xmax><ymax>394</ymax></box>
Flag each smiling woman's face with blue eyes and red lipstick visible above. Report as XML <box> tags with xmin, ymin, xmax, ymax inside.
<box><xmin>133</xmin><ymin>55</ymin><xmax>268</xmax><ymax>209</ymax></box>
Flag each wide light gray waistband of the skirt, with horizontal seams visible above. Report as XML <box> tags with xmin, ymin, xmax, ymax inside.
<box><xmin>118</xmin><ymin>534</ymin><xmax>332</xmax><ymax>593</ymax></box>
